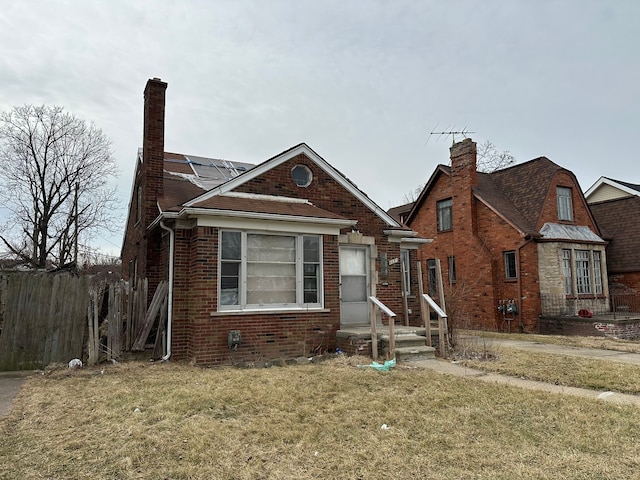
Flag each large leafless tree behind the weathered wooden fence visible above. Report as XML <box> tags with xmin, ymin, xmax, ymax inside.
<box><xmin>0</xmin><ymin>105</ymin><xmax>117</xmax><ymax>268</ymax></box>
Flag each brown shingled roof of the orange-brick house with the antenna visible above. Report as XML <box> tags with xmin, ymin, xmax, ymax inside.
<box><xmin>406</xmin><ymin>157</ymin><xmax>597</xmax><ymax>238</ymax></box>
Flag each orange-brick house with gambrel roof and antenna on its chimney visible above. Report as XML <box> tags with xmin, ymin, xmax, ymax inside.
<box><xmin>405</xmin><ymin>139</ymin><xmax>608</xmax><ymax>332</ymax></box>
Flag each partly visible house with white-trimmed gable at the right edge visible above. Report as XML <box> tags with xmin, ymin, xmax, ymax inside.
<box><xmin>585</xmin><ymin>177</ymin><xmax>640</xmax><ymax>294</ymax></box>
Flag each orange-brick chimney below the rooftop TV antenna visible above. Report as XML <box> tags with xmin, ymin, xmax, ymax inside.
<box><xmin>450</xmin><ymin>138</ymin><xmax>478</xmax><ymax>235</ymax></box>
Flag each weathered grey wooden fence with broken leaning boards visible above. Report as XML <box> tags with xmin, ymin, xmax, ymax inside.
<box><xmin>0</xmin><ymin>273</ymin><xmax>168</xmax><ymax>371</ymax></box>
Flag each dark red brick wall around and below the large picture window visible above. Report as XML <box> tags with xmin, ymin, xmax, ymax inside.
<box><xmin>172</xmin><ymin>227</ymin><xmax>340</xmax><ymax>364</ymax></box>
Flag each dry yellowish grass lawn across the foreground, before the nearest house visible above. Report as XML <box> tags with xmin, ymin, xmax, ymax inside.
<box><xmin>0</xmin><ymin>359</ymin><xmax>640</xmax><ymax>480</ymax></box>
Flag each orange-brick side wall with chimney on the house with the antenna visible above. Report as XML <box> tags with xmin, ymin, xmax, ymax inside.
<box><xmin>409</xmin><ymin>144</ymin><xmax>544</xmax><ymax>331</ymax></box>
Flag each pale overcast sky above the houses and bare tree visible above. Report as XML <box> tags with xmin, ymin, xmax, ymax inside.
<box><xmin>0</xmin><ymin>0</ymin><xmax>640</xmax><ymax>252</ymax></box>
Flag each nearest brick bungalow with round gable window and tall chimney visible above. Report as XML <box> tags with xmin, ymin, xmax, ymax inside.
<box><xmin>122</xmin><ymin>79</ymin><xmax>424</xmax><ymax>364</ymax></box>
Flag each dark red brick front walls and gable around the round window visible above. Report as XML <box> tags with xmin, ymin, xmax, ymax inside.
<box><xmin>164</xmin><ymin>155</ymin><xmax>420</xmax><ymax>364</ymax></box>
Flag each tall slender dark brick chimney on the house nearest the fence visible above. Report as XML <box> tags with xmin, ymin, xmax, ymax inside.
<box><xmin>141</xmin><ymin>78</ymin><xmax>167</xmax><ymax>226</ymax></box>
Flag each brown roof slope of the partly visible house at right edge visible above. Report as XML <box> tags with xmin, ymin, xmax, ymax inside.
<box><xmin>589</xmin><ymin>195</ymin><xmax>640</xmax><ymax>273</ymax></box>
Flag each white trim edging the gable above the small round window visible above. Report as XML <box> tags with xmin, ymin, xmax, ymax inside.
<box><xmin>184</xmin><ymin>143</ymin><xmax>401</xmax><ymax>227</ymax></box>
